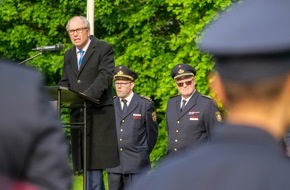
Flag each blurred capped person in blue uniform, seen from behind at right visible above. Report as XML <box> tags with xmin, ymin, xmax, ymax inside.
<box><xmin>132</xmin><ymin>0</ymin><xmax>290</xmax><ymax>190</ymax></box>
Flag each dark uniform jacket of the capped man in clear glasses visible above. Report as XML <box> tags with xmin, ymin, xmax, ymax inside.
<box><xmin>108</xmin><ymin>94</ymin><xmax>158</xmax><ymax>174</ymax></box>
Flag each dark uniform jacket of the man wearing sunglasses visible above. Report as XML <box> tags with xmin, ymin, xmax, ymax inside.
<box><xmin>166</xmin><ymin>91</ymin><xmax>220</xmax><ymax>155</ymax></box>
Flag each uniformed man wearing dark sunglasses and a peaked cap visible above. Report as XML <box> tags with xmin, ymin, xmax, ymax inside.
<box><xmin>166</xmin><ymin>64</ymin><xmax>221</xmax><ymax>155</ymax></box>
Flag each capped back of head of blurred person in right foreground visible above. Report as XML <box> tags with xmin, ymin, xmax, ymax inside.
<box><xmin>199</xmin><ymin>0</ymin><xmax>290</xmax><ymax>137</ymax></box>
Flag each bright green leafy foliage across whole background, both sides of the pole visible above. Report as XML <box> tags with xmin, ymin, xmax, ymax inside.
<box><xmin>0</xmin><ymin>0</ymin><xmax>234</xmax><ymax>162</ymax></box>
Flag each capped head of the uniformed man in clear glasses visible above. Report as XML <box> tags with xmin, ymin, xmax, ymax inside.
<box><xmin>114</xmin><ymin>65</ymin><xmax>138</xmax><ymax>98</ymax></box>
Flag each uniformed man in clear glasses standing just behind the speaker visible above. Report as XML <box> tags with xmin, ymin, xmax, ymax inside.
<box><xmin>107</xmin><ymin>65</ymin><xmax>158</xmax><ymax>190</ymax></box>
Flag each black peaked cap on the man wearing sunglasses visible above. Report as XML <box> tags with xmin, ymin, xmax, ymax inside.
<box><xmin>171</xmin><ymin>63</ymin><xmax>196</xmax><ymax>80</ymax></box>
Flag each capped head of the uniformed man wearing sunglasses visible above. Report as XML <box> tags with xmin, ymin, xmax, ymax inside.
<box><xmin>171</xmin><ymin>63</ymin><xmax>196</xmax><ymax>98</ymax></box>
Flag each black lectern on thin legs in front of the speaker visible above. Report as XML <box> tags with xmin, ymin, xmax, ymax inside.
<box><xmin>45</xmin><ymin>86</ymin><xmax>99</xmax><ymax>190</ymax></box>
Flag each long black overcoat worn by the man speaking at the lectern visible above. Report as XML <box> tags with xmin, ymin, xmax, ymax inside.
<box><xmin>59</xmin><ymin>36</ymin><xmax>119</xmax><ymax>171</ymax></box>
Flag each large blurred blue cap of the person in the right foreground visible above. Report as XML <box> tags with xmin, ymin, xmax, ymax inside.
<box><xmin>200</xmin><ymin>0</ymin><xmax>290</xmax><ymax>82</ymax></box>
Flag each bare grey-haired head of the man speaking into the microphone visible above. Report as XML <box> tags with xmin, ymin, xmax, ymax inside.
<box><xmin>66</xmin><ymin>16</ymin><xmax>90</xmax><ymax>49</ymax></box>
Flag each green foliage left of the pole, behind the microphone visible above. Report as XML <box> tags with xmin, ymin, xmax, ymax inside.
<box><xmin>0</xmin><ymin>0</ymin><xmax>86</xmax><ymax>84</ymax></box>
